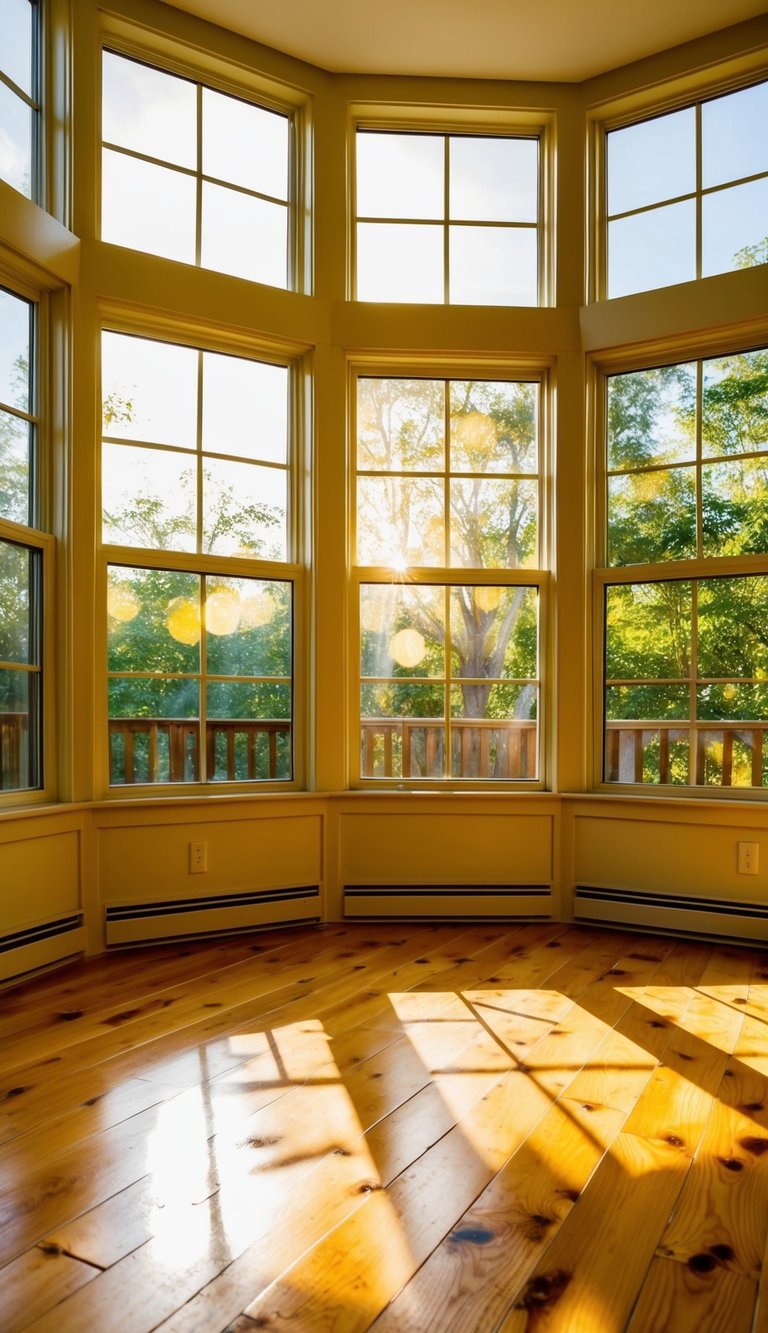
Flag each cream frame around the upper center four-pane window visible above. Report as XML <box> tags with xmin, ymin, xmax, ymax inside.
<box><xmin>347</xmin><ymin>103</ymin><xmax>556</xmax><ymax>311</ymax></box>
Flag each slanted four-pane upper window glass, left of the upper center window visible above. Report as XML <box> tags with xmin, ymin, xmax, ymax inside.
<box><xmin>101</xmin><ymin>51</ymin><xmax>293</xmax><ymax>288</ymax></box>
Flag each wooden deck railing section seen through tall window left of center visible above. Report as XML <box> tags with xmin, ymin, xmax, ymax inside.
<box><xmin>109</xmin><ymin>717</ymin><xmax>291</xmax><ymax>784</ymax></box>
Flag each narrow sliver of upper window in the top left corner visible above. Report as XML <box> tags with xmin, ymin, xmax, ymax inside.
<box><xmin>0</xmin><ymin>0</ymin><xmax>40</xmax><ymax>199</ymax></box>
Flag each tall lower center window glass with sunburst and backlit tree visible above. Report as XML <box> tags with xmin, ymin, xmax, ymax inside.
<box><xmin>355</xmin><ymin>375</ymin><xmax>543</xmax><ymax>781</ymax></box>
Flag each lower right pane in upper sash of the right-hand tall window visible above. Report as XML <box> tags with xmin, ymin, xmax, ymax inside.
<box><xmin>701</xmin><ymin>456</ymin><xmax>768</xmax><ymax>556</ymax></box>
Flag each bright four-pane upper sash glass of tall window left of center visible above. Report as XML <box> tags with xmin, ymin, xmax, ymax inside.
<box><xmin>101</xmin><ymin>332</ymin><xmax>289</xmax><ymax>561</ymax></box>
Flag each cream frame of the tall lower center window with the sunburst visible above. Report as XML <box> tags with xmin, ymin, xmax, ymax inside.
<box><xmin>347</xmin><ymin>355</ymin><xmax>555</xmax><ymax>794</ymax></box>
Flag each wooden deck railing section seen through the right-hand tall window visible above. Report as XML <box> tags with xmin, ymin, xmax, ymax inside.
<box><xmin>605</xmin><ymin>718</ymin><xmax>768</xmax><ymax>786</ymax></box>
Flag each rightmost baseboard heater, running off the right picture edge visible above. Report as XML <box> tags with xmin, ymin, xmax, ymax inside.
<box><xmin>573</xmin><ymin>884</ymin><xmax>768</xmax><ymax>942</ymax></box>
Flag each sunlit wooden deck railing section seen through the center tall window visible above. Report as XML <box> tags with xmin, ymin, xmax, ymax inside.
<box><xmin>360</xmin><ymin>717</ymin><xmax>537</xmax><ymax>781</ymax></box>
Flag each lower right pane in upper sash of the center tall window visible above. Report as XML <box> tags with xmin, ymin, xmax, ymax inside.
<box><xmin>451</xmin><ymin>477</ymin><xmax>537</xmax><ymax>569</ymax></box>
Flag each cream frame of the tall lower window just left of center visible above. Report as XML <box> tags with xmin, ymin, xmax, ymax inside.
<box><xmin>96</xmin><ymin>313</ymin><xmax>309</xmax><ymax>800</ymax></box>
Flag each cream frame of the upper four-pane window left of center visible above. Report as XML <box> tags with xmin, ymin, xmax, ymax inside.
<box><xmin>95</xmin><ymin>35</ymin><xmax>312</xmax><ymax>295</ymax></box>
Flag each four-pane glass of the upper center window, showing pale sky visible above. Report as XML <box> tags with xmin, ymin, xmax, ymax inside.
<box><xmin>356</xmin><ymin>129</ymin><xmax>540</xmax><ymax>305</ymax></box>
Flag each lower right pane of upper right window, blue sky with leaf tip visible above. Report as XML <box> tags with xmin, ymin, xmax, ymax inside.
<box><xmin>701</xmin><ymin>180</ymin><xmax>768</xmax><ymax>277</ymax></box>
